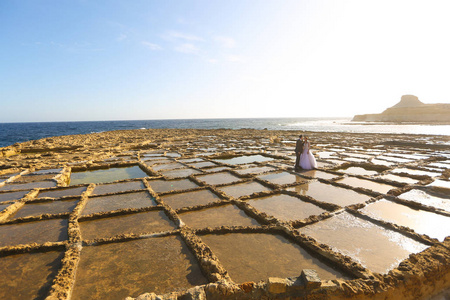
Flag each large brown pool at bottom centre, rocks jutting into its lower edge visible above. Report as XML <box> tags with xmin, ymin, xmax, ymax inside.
<box><xmin>200</xmin><ymin>233</ymin><xmax>347</xmax><ymax>283</ymax></box>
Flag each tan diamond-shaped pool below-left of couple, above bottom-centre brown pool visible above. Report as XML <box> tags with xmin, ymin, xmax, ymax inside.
<box><xmin>247</xmin><ymin>195</ymin><xmax>325</xmax><ymax>221</ymax></box>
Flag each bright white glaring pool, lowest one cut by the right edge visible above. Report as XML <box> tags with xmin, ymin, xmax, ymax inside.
<box><xmin>361</xmin><ymin>199</ymin><xmax>450</xmax><ymax>242</ymax></box>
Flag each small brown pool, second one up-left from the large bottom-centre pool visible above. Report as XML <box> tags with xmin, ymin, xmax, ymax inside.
<box><xmin>161</xmin><ymin>190</ymin><xmax>221</xmax><ymax>209</ymax></box>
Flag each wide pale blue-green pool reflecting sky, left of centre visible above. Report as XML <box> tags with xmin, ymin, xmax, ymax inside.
<box><xmin>70</xmin><ymin>166</ymin><xmax>148</xmax><ymax>185</ymax></box>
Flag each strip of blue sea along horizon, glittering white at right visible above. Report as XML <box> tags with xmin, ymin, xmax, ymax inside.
<box><xmin>0</xmin><ymin>118</ymin><xmax>450</xmax><ymax>147</ymax></box>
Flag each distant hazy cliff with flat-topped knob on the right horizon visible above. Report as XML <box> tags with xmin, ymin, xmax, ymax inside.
<box><xmin>352</xmin><ymin>95</ymin><xmax>450</xmax><ymax>123</ymax></box>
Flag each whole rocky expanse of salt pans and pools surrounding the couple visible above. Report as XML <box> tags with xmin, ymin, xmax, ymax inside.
<box><xmin>0</xmin><ymin>129</ymin><xmax>450</xmax><ymax>299</ymax></box>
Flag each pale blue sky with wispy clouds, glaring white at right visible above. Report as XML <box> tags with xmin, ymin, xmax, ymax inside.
<box><xmin>0</xmin><ymin>0</ymin><xmax>450</xmax><ymax>122</ymax></box>
